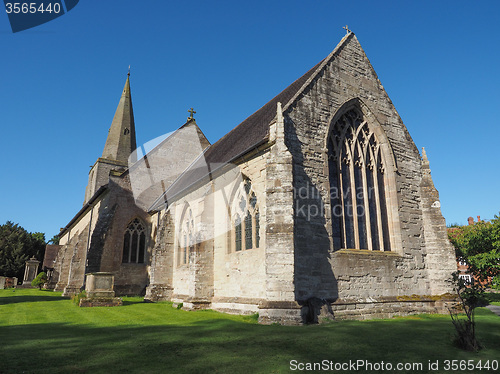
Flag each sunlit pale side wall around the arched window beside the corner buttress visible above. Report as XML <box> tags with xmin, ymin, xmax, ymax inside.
<box><xmin>212</xmin><ymin>152</ymin><xmax>269</xmax><ymax>313</ymax></box>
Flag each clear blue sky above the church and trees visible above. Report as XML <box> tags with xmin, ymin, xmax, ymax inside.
<box><xmin>0</xmin><ymin>0</ymin><xmax>500</xmax><ymax>239</ymax></box>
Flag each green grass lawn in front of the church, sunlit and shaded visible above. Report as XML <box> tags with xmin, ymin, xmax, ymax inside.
<box><xmin>0</xmin><ymin>289</ymin><xmax>500</xmax><ymax>374</ymax></box>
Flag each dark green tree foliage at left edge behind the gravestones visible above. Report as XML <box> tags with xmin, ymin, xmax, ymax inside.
<box><xmin>0</xmin><ymin>221</ymin><xmax>46</xmax><ymax>279</ymax></box>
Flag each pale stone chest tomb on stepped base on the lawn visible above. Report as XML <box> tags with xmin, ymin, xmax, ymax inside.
<box><xmin>79</xmin><ymin>273</ymin><xmax>122</xmax><ymax>307</ymax></box>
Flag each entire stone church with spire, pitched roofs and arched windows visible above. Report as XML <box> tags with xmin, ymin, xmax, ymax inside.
<box><xmin>44</xmin><ymin>32</ymin><xmax>456</xmax><ymax>323</ymax></box>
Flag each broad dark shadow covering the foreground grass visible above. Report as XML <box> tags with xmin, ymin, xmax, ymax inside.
<box><xmin>0</xmin><ymin>311</ymin><xmax>500</xmax><ymax>373</ymax></box>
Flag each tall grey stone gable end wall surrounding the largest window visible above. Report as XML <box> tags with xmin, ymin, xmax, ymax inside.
<box><xmin>285</xmin><ymin>34</ymin><xmax>452</xmax><ymax>308</ymax></box>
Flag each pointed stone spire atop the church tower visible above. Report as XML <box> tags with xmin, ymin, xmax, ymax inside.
<box><xmin>102</xmin><ymin>74</ymin><xmax>137</xmax><ymax>164</ymax></box>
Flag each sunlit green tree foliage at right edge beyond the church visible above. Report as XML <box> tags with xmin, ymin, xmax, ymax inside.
<box><xmin>448</xmin><ymin>216</ymin><xmax>500</xmax><ymax>280</ymax></box>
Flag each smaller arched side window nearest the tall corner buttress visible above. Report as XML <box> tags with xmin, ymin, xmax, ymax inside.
<box><xmin>233</xmin><ymin>179</ymin><xmax>260</xmax><ymax>252</ymax></box>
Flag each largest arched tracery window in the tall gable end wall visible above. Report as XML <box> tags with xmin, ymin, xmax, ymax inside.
<box><xmin>328</xmin><ymin>109</ymin><xmax>391</xmax><ymax>251</ymax></box>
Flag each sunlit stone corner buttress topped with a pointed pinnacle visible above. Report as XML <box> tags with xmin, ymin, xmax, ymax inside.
<box><xmin>259</xmin><ymin>103</ymin><xmax>298</xmax><ymax>323</ymax></box>
